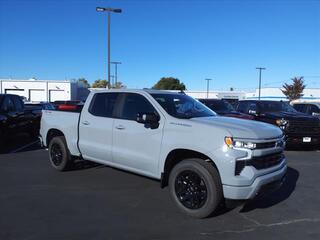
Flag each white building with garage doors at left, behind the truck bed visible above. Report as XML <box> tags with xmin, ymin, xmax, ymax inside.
<box><xmin>0</xmin><ymin>79</ymin><xmax>89</xmax><ymax>102</ymax></box>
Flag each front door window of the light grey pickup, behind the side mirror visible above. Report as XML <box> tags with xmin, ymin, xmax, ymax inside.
<box><xmin>120</xmin><ymin>93</ymin><xmax>158</xmax><ymax>121</ymax></box>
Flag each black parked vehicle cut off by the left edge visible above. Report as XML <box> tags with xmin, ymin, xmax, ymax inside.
<box><xmin>0</xmin><ymin>94</ymin><xmax>40</xmax><ymax>145</ymax></box>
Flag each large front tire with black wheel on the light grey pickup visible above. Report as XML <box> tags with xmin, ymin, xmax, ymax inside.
<box><xmin>169</xmin><ymin>158</ymin><xmax>223</xmax><ymax>218</ymax></box>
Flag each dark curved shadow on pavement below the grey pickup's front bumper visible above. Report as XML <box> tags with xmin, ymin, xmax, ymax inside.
<box><xmin>240</xmin><ymin>167</ymin><xmax>299</xmax><ymax>212</ymax></box>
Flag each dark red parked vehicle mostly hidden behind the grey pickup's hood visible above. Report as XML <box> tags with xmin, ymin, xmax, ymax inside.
<box><xmin>198</xmin><ymin>98</ymin><xmax>254</xmax><ymax>120</ymax></box>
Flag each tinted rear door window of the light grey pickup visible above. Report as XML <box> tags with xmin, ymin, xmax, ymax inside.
<box><xmin>89</xmin><ymin>93</ymin><xmax>119</xmax><ymax>117</ymax></box>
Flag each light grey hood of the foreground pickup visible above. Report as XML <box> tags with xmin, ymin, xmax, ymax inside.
<box><xmin>190</xmin><ymin>116</ymin><xmax>282</xmax><ymax>139</ymax></box>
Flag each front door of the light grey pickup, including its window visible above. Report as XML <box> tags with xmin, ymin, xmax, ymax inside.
<box><xmin>112</xmin><ymin>93</ymin><xmax>164</xmax><ymax>176</ymax></box>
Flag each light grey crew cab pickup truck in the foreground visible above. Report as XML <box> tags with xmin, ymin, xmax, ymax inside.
<box><xmin>40</xmin><ymin>90</ymin><xmax>287</xmax><ymax>218</ymax></box>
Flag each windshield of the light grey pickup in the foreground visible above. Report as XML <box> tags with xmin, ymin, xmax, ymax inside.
<box><xmin>151</xmin><ymin>94</ymin><xmax>216</xmax><ymax>119</ymax></box>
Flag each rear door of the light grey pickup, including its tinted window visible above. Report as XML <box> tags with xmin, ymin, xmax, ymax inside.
<box><xmin>79</xmin><ymin>92</ymin><xmax>119</xmax><ymax>163</ymax></box>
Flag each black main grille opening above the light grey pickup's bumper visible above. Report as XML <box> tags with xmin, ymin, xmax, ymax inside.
<box><xmin>235</xmin><ymin>152</ymin><xmax>284</xmax><ymax>175</ymax></box>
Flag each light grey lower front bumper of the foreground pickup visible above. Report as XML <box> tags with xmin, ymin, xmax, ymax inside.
<box><xmin>222</xmin><ymin>162</ymin><xmax>287</xmax><ymax>200</ymax></box>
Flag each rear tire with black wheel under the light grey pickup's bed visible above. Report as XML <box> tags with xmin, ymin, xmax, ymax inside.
<box><xmin>49</xmin><ymin>136</ymin><xmax>73</xmax><ymax>171</ymax></box>
